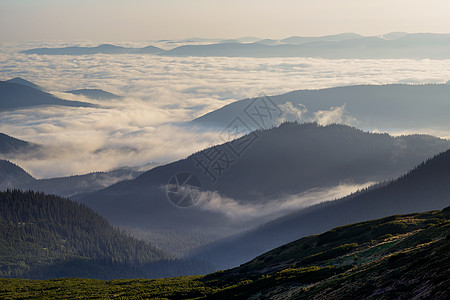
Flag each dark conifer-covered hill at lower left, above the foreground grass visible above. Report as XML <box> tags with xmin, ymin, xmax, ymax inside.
<box><xmin>0</xmin><ymin>190</ymin><xmax>213</xmax><ymax>279</ymax></box>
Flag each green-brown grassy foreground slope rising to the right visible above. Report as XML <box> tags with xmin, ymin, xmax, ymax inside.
<box><xmin>0</xmin><ymin>208</ymin><xmax>450</xmax><ymax>299</ymax></box>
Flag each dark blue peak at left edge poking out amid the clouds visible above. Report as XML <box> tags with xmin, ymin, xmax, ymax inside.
<box><xmin>0</xmin><ymin>81</ymin><xmax>93</xmax><ymax>110</ymax></box>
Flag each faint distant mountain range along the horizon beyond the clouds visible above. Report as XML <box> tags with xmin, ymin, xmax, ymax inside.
<box><xmin>22</xmin><ymin>32</ymin><xmax>450</xmax><ymax>59</ymax></box>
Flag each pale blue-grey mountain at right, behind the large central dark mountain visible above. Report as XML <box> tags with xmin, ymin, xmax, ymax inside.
<box><xmin>193</xmin><ymin>84</ymin><xmax>450</xmax><ymax>132</ymax></box>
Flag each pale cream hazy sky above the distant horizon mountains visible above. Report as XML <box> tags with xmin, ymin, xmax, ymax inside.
<box><xmin>0</xmin><ymin>0</ymin><xmax>450</xmax><ymax>42</ymax></box>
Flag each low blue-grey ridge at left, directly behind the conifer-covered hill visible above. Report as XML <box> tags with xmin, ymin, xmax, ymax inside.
<box><xmin>0</xmin><ymin>160</ymin><xmax>151</xmax><ymax>197</ymax></box>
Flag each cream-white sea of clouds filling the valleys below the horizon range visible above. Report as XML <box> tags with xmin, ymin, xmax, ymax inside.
<box><xmin>0</xmin><ymin>42</ymin><xmax>450</xmax><ymax>178</ymax></box>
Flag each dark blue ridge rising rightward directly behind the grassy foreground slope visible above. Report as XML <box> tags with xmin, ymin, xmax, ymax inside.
<box><xmin>193</xmin><ymin>146</ymin><xmax>450</xmax><ymax>268</ymax></box>
